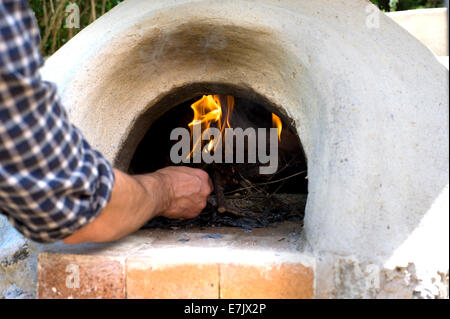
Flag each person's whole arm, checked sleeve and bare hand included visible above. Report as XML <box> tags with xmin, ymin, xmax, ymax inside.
<box><xmin>0</xmin><ymin>0</ymin><xmax>210</xmax><ymax>243</ymax></box>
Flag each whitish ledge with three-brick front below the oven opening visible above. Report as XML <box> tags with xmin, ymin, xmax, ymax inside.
<box><xmin>38</xmin><ymin>222</ymin><xmax>315</xmax><ymax>299</ymax></box>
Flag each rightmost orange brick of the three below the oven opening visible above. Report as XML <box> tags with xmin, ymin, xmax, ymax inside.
<box><xmin>220</xmin><ymin>263</ymin><xmax>314</xmax><ymax>299</ymax></box>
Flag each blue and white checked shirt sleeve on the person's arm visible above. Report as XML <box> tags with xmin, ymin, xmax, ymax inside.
<box><xmin>0</xmin><ymin>0</ymin><xmax>114</xmax><ymax>242</ymax></box>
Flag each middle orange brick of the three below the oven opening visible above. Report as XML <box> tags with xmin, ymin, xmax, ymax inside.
<box><xmin>127</xmin><ymin>259</ymin><xmax>219</xmax><ymax>299</ymax></box>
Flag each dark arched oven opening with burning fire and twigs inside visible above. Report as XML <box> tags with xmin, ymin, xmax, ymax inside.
<box><xmin>128</xmin><ymin>93</ymin><xmax>308</xmax><ymax>232</ymax></box>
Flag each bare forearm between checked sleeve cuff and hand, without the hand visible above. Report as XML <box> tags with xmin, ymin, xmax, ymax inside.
<box><xmin>63</xmin><ymin>170</ymin><xmax>164</xmax><ymax>244</ymax></box>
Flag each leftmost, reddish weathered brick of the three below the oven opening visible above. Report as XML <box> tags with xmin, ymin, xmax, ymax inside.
<box><xmin>38</xmin><ymin>253</ymin><xmax>125</xmax><ymax>299</ymax></box>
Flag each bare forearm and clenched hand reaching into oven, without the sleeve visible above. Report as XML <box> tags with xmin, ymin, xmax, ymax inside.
<box><xmin>63</xmin><ymin>167</ymin><xmax>212</xmax><ymax>244</ymax></box>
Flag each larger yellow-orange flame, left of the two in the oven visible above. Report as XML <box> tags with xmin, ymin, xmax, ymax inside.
<box><xmin>188</xmin><ymin>95</ymin><xmax>234</xmax><ymax>158</ymax></box>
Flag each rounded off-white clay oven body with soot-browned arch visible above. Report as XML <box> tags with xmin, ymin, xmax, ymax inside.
<box><xmin>7</xmin><ymin>0</ymin><xmax>448</xmax><ymax>297</ymax></box>
